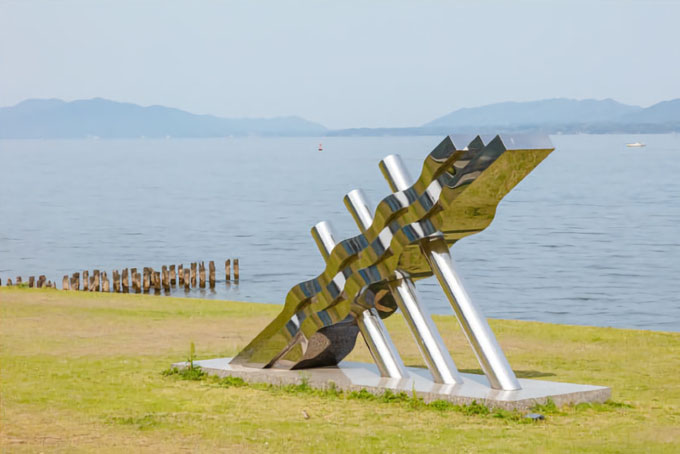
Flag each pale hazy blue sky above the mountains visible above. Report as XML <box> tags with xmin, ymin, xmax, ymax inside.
<box><xmin>0</xmin><ymin>0</ymin><xmax>680</xmax><ymax>128</ymax></box>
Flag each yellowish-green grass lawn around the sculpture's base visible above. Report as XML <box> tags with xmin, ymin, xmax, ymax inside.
<box><xmin>0</xmin><ymin>287</ymin><xmax>680</xmax><ymax>453</ymax></box>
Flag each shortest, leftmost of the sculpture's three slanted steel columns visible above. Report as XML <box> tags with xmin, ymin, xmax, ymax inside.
<box><xmin>312</xmin><ymin>221</ymin><xmax>408</xmax><ymax>379</ymax></box>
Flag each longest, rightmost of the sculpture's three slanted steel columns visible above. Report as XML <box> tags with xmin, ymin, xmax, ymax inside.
<box><xmin>380</xmin><ymin>155</ymin><xmax>521</xmax><ymax>391</ymax></box>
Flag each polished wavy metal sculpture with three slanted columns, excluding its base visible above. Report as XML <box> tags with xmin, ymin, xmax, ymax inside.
<box><xmin>231</xmin><ymin>136</ymin><xmax>554</xmax><ymax>391</ymax></box>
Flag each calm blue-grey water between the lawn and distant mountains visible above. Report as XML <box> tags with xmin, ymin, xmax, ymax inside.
<box><xmin>0</xmin><ymin>135</ymin><xmax>680</xmax><ymax>331</ymax></box>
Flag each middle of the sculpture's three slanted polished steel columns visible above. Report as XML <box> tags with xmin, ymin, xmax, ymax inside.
<box><xmin>345</xmin><ymin>189</ymin><xmax>463</xmax><ymax>384</ymax></box>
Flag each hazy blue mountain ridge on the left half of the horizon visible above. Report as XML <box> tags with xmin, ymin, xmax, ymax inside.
<box><xmin>0</xmin><ymin>98</ymin><xmax>326</xmax><ymax>138</ymax></box>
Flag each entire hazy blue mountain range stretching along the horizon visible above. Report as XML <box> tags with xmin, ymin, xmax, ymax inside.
<box><xmin>0</xmin><ymin>98</ymin><xmax>680</xmax><ymax>139</ymax></box>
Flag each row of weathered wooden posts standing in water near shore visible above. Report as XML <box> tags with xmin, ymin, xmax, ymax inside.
<box><xmin>0</xmin><ymin>259</ymin><xmax>239</xmax><ymax>293</ymax></box>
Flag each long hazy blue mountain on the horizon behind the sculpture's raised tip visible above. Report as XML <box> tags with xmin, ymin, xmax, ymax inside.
<box><xmin>423</xmin><ymin>99</ymin><xmax>643</xmax><ymax>128</ymax></box>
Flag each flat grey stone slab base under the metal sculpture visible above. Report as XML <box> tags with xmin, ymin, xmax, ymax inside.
<box><xmin>173</xmin><ymin>358</ymin><xmax>611</xmax><ymax>410</ymax></box>
